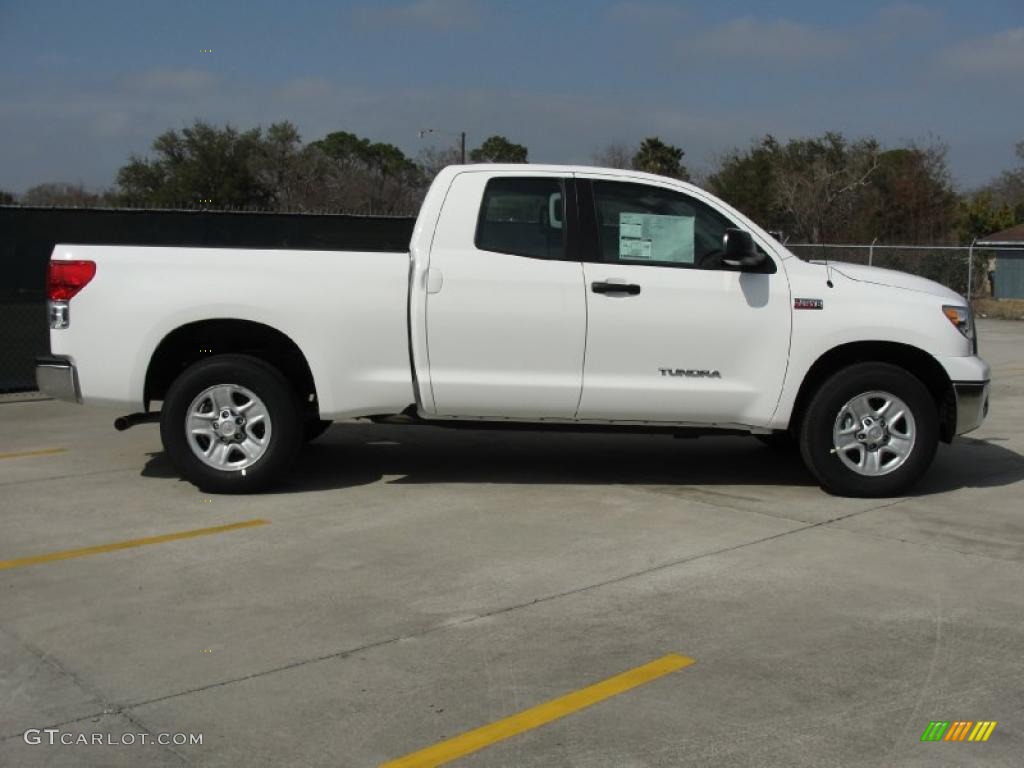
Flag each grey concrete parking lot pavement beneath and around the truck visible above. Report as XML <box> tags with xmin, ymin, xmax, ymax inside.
<box><xmin>0</xmin><ymin>322</ymin><xmax>1024</xmax><ymax>767</ymax></box>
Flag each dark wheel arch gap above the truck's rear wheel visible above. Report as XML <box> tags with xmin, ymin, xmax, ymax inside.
<box><xmin>142</xmin><ymin>317</ymin><xmax>317</xmax><ymax>410</ymax></box>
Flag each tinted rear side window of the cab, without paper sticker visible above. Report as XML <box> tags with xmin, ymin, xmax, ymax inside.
<box><xmin>476</xmin><ymin>178</ymin><xmax>565</xmax><ymax>259</ymax></box>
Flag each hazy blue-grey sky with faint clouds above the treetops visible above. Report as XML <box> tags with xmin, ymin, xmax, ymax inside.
<box><xmin>0</xmin><ymin>0</ymin><xmax>1024</xmax><ymax>193</ymax></box>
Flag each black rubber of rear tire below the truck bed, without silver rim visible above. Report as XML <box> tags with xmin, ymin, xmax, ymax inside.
<box><xmin>160</xmin><ymin>354</ymin><xmax>303</xmax><ymax>494</ymax></box>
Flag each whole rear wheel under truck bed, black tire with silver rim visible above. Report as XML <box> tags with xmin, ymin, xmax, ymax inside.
<box><xmin>160</xmin><ymin>354</ymin><xmax>303</xmax><ymax>494</ymax></box>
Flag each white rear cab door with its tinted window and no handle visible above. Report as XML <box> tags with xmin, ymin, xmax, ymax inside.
<box><xmin>426</xmin><ymin>171</ymin><xmax>587</xmax><ymax>419</ymax></box>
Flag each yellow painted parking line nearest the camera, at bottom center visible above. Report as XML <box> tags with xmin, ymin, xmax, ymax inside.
<box><xmin>380</xmin><ymin>653</ymin><xmax>694</xmax><ymax>768</ymax></box>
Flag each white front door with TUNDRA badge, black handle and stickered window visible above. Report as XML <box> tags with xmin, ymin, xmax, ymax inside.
<box><xmin>578</xmin><ymin>175</ymin><xmax>791</xmax><ymax>425</ymax></box>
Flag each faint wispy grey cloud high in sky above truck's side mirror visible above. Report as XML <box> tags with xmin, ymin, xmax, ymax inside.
<box><xmin>680</xmin><ymin>16</ymin><xmax>853</xmax><ymax>65</ymax></box>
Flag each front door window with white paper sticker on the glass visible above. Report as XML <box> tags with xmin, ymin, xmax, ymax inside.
<box><xmin>593</xmin><ymin>181</ymin><xmax>749</xmax><ymax>269</ymax></box>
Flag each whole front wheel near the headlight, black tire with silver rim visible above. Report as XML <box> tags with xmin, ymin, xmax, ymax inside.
<box><xmin>800</xmin><ymin>362</ymin><xmax>939</xmax><ymax>497</ymax></box>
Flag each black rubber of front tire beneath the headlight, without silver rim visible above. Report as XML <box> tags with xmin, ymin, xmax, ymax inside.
<box><xmin>800</xmin><ymin>362</ymin><xmax>939</xmax><ymax>497</ymax></box>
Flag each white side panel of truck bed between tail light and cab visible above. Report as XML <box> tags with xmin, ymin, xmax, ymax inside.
<box><xmin>52</xmin><ymin>245</ymin><xmax>415</xmax><ymax>419</ymax></box>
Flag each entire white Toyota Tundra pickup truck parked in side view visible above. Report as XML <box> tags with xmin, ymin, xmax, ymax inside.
<box><xmin>37</xmin><ymin>165</ymin><xmax>989</xmax><ymax>496</ymax></box>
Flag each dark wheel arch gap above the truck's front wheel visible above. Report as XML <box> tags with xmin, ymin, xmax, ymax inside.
<box><xmin>790</xmin><ymin>341</ymin><xmax>956</xmax><ymax>442</ymax></box>
